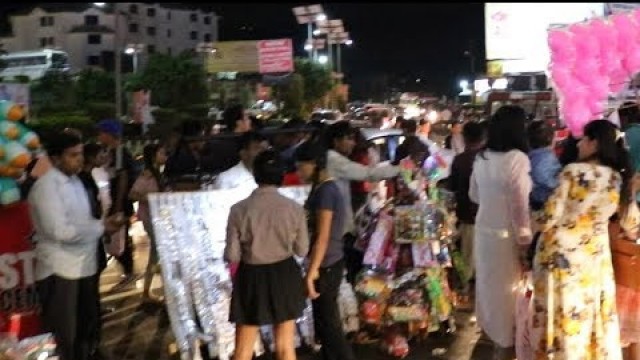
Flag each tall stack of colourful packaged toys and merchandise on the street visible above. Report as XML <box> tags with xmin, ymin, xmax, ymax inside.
<box><xmin>355</xmin><ymin>159</ymin><xmax>464</xmax><ymax>357</ymax></box>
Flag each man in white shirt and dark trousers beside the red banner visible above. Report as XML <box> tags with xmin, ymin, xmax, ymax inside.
<box><xmin>28</xmin><ymin>132</ymin><xmax>125</xmax><ymax>360</ymax></box>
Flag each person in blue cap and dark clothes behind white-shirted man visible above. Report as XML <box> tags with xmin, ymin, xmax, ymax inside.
<box><xmin>98</xmin><ymin>119</ymin><xmax>136</xmax><ymax>285</ymax></box>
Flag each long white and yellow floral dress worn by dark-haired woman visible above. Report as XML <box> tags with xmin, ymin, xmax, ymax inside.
<box><xmin>532</xmin><ymin>163</ymin><xmax>622</xmax><ymax>360</ymax></box>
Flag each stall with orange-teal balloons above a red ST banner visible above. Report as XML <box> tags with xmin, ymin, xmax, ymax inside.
<box><xmin>0</xmin><ymin>101</ymin><xmax>55</xmax><ymax>360</ymax></box>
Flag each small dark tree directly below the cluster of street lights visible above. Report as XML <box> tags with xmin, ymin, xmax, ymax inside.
<box><xmin>295</xmin><ymin>58</ymin><xmax>333</xmax><ymax>108</ymax></box>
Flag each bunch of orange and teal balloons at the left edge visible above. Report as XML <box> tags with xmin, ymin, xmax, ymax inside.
<box><xmin>0</xmin><ymin>101</ymin><xmax>40</xmax><ymax>206</ymax></box>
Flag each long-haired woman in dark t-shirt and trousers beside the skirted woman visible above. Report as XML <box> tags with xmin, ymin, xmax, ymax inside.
<box><xmin>295</xmin><ymin>142</ymin><xmax>355</xmax><ymax>360</ymax></box>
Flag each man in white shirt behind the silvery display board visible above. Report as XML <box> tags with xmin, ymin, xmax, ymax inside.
<box><xmin>213</xmin><ymin>131</ymin><xmax>269</xmax><ymax>189</ymax></box>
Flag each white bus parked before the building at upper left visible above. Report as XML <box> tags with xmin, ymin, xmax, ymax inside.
<box><xmin>0</xmin><ymin>49</ymin><xmax>69</xmax><ymax>81</ymax></box>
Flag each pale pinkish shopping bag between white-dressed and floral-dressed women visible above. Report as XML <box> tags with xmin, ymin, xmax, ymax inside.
<box><xmin>515</xmin><ymin>272</ymin><xmax>533</xmax><ymax>360</ymax></box>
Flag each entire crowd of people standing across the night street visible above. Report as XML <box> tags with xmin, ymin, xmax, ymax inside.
<box><xmin>13</xmin><ymin>98</ymin><xmax>640</xmax><ymax>360</ymax></box>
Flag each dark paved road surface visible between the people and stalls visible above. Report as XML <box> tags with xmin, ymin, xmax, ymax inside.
<box><xmin>100</xmin><ymin>225</ymin><xmax>491</xmax><ymax>360</ymax></box>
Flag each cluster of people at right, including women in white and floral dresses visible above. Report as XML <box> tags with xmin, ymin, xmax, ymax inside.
<box><xmin>449</xmin><ymin>104</ymin><xmax>640</xmax><ymax>359</ymax></box>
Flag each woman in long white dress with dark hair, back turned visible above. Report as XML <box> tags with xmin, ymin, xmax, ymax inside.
<box><xmin>469</xmin><ymin>105</ymin><xmax>532</xmax><ymax>360</ymax></box>
